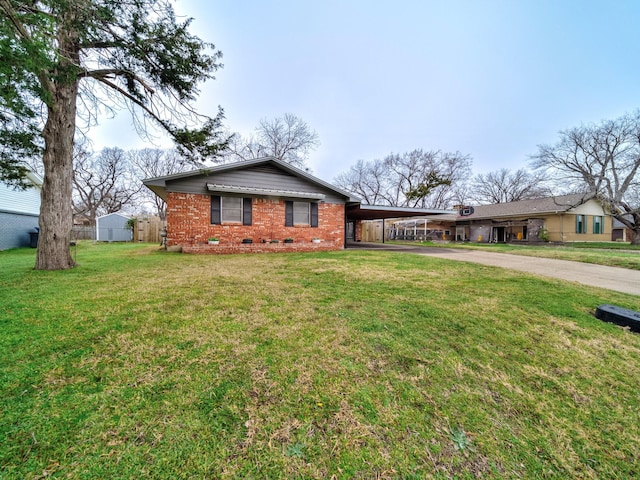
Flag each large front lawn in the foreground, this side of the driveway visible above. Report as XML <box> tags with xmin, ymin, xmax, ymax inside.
<box><xmin>0</xmin><ymin>243</ymin><xmax>640</xmax><ymax>480</ymax></box>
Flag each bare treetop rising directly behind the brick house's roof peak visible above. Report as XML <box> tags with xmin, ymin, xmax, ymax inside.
<box><xmin>226</xmin><ymin>113</ymin><xmax>320</xmax><ymax>169</ymax></box>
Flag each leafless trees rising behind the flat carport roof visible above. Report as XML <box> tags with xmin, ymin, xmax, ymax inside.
<box><xmin>335</xmin><ymin>149</ymin><xmax>471</xmax><ymax>209</ymax></box>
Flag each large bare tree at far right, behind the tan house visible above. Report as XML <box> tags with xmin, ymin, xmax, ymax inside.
<box><xmin>532</xmin><ymin>111</ymin><xmax>640</xmax><ymax>245</ymax></box>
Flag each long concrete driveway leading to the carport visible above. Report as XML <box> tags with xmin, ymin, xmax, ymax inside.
<box><xmin>348</xmin><ymin>242</ymin><xmax>640</xmax><ymax>296</ymax></box>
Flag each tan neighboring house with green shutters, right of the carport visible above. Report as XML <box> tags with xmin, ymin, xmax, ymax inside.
<box><xmin>454</xmin><ymin>194</ymin><xmax>612</xmax><ymax>242</ymax></box>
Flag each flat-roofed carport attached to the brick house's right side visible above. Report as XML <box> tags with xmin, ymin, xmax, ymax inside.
<box><xmin>345</xmin><ymin>203</ymin><xmax>458</xmax><ymax>247</ymax></box>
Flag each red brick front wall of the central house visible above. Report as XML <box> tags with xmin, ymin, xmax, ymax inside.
<box><xmin>167</xmin><ymin>192</ymin><xmax>345</xmax><ymax>253</ymax></box>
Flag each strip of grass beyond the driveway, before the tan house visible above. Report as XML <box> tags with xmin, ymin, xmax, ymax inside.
<box><xmin>408</xmin><ymin>242</ymin><xmax>640</xmax><ymax>270</ymax></box>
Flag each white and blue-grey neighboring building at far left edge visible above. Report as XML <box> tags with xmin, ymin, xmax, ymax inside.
<box><xmin>0</xmin><ymin>173</ymin><xmax>42</xmax><ymax>250</ymax></box>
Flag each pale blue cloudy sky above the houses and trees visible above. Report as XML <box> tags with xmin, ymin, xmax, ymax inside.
<box><xmin>91</xmin><ymin>0</ymin><xmax>640</xmax><ymax>181</ymax></box>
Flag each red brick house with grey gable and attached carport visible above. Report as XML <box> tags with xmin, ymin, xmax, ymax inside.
<box><xmin>143</xmin><ymin>157</ymin><xmax>452</xmax><ymax>253</ymax></box>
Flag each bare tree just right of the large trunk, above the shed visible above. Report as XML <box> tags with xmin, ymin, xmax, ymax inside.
<box><xmin>73</xmin><ymin>148</ymin><xmax>142</xmax><ymax>225</ymax></box>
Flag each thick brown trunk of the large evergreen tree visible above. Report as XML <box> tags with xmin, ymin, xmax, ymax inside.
<box><xmin>36</xmin><ymin>19</ymin><xmax>80</xmax><ymax>270</ymax></box>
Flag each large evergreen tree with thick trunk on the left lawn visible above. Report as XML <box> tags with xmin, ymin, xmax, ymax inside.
<box><xmin>0</xmin><ymin>0</ymin><xmax>226</xmax><ymax>269</ymax></box>
